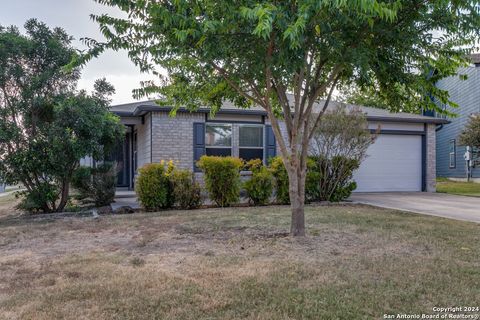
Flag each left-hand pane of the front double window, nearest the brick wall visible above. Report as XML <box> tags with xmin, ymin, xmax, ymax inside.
<box><xmin>205</xmin><ymin>124</ymin><xmax>232</xmax><ymax>157</ymax></box>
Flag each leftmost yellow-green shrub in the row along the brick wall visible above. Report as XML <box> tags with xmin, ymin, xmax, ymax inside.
<box><xmin>135</xmin><ymin>162</ymin><xmax>174</xmax><ymax>211</ymax></box>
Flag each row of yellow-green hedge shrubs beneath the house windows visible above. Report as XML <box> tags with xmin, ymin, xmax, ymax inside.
<box><xmin>135</xmin><ymin>156</ymin><xmax>359</xmax><ymax>210</ymax></box>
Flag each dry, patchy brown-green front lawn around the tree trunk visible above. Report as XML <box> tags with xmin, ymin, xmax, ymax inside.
<box><xmin>0</xmin><ymin>205</ymin><xmax>480</xmax><ymax>320</ymax></box>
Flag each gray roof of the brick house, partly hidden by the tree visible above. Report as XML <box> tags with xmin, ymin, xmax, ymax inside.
<box><xmin>110</xmin><ymin>95</ymin><xmax>449</xmax><ymax>124</ymax></box>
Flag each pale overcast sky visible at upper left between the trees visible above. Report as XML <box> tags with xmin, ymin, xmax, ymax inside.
<box><xmin>0</xmin><ymin>0</ymin><xmax>152</xmax><ymax>104</ymax></box>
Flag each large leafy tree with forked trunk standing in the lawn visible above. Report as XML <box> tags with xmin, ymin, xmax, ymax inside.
<box><xmin>77</xmin><ymin>0</ymin><xmax>480</xmax><ymax>236</ymax></box>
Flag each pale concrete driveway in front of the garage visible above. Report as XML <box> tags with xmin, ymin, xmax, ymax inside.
<box><xmin>350</xmin><ymin>192</ymin><xmax>480</xmax><ymax>223</ymax></box>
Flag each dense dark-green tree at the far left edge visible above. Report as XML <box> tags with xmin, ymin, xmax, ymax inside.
<box><xmin>0</xmin><ymin>20</ymin><xmax>123</xmax><ymax>212</ymax></box>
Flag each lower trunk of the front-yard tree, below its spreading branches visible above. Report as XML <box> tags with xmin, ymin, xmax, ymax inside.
<box><xmin>288</xmin><ymin>164</ymin><xmax>306</xmax><ymax>237</ymax></box>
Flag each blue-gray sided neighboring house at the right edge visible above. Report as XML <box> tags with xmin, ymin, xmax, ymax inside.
<box><xmin>437</xmin><ymin>54</ymin><xmax>480</xmax><ymax>179</ymax></box>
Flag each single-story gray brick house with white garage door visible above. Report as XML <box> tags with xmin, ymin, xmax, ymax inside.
<box><xmin>107</xmin><ymin>101</ymin><xmax>446</xmax><ymax>192</ymax></box>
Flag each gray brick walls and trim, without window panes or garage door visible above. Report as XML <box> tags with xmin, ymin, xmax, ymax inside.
<box><xmin>109</xmin><ymin>103</ymin><xmax>438</xmax><ymax>192</ymax></box>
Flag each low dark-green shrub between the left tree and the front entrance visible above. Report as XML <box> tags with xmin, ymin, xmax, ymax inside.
<box><xmin>72</xmin><ymin>162</ymin><xmax>117</xmax><ymax>207</ymax></box>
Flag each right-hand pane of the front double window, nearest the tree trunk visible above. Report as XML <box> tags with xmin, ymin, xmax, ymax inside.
<box><xmin>238</xmin><ymin>124</ymin><xmax>264</xmax><ymax>161</ymax></box>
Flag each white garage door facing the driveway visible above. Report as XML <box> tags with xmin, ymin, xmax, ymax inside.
<box><xmin>353</xmin><ymin>134</ymin><xmax>422</xmax><ymax>192</ymax></box>
